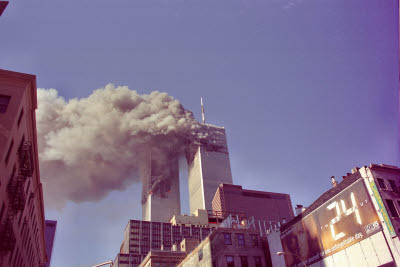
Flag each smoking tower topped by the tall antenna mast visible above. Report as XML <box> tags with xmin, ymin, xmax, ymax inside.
<box><xmin>186</xmin><ymin>123</ymin><xmax>232</xmax><ymax>216</ymax></box>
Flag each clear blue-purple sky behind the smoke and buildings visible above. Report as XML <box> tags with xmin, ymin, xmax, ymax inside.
<box><xmin>0</xmin><ymin>0</ymin><xmax>400</xmax><ymax>267</ymax></box>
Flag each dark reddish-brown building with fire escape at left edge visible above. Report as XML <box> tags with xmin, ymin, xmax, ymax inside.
<box><xmin>0</xmin><ymin>70</ymin><xmax>47</xmax><ymax>267</ymax></box>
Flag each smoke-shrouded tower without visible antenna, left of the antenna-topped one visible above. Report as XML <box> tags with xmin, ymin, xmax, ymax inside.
<box><xmin>142</xmin><ymin>148</ymin><xmax>181</xmax><ymax>222</ymax></box>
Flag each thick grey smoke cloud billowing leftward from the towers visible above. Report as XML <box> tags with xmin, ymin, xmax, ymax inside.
<box><xmin>36</xmin><ymin>84</ymin><xmax>202</xmax><ymax>208</ymax></box>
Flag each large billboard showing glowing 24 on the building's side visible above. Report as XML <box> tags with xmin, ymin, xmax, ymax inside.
<box><xmin>281</xmin><ymin>179</ymin><xmax>382</xmax><ymax>266</ymax></box>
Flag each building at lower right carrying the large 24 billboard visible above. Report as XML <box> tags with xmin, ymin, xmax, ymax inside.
<box><xmin>276</xmin><ymin>164</ymin><xmax>400</xmax><ymax>267</ymax></box>
